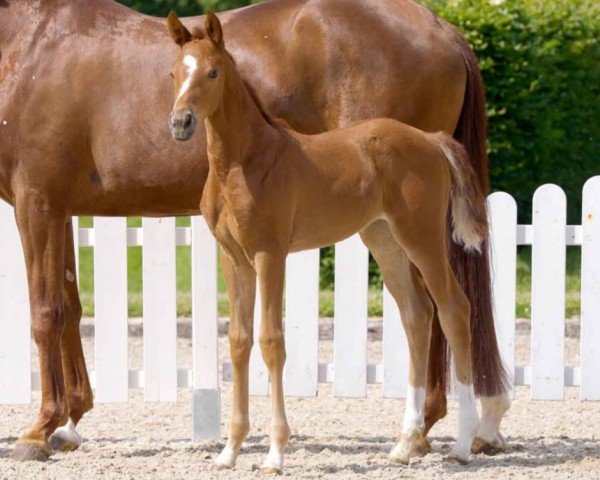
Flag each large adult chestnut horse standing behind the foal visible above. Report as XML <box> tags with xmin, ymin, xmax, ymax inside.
<box><xmin>0</xmin><ymin>0</ymin><xmax>508</xmax><ymax>460</ymax></box>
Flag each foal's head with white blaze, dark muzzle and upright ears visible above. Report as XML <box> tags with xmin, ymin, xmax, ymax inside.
<box><xmin>168</xmin><ymin>12</ymin><xmax>231</xmax><ymax>141</ymax></box>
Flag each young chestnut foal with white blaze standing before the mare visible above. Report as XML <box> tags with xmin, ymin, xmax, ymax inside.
<box><xmin>169</xmin><ymin>13</ymin><xmax>487</xmax><ymax>473</ymax></box>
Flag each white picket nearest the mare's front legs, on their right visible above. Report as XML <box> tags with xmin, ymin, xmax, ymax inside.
<box><xmin>94</xmin><ymin>217</ymin><xmax>129</xmax><ymax>403</ymax></box>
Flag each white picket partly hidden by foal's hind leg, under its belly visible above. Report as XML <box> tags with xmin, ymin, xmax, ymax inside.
<box><xmin>383</xmin><ymin>287</ymin><xmax>410</xmax><ymax>398</ymax></box>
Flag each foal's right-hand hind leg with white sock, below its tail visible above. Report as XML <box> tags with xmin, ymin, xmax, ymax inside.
<box><xmin>390</xmin><ymin>218</ymin><xmax>479</xmax><ymax>463</ymax></box>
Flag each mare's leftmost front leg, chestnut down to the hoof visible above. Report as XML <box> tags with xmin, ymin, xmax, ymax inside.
<box><xmin>12</xmin><ymin>191</ymin><xmax>69</xmax><ymax>460</ymax></box>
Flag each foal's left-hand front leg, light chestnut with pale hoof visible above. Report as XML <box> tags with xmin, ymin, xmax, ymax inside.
<box><xmin>215</xmin><ymin>249</ymin><xmax>256</xmax><ymax>468</ymax></box>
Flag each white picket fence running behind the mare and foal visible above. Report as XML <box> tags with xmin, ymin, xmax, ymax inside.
<box><xmin>0</xmin><ymin>176</ymin><xmax>600</xmax><ymax>440</ymax></box>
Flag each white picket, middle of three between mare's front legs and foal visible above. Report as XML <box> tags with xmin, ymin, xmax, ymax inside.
<box><xmin>142</xmin><ymin>218</ymin><xmax>177</xmax><ymax>402</ymax></box>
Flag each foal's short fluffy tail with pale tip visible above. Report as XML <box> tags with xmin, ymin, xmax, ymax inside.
<box><xmin>435</xmin><ymin>132</ymin><xmax>488</xmax><ymax>253</ymax></box>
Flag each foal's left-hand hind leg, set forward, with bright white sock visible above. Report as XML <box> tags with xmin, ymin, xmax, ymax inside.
<box><xmin>360</xmin><ymin>221</ymin><xmax>433</xmax><ymax>464</ymax></box>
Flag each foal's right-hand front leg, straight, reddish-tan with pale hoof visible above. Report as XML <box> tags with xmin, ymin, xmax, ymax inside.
<box><xmin>254</xmin><ymin>252</ymin><xmax>290</xmax><ymax>474</ymax></box>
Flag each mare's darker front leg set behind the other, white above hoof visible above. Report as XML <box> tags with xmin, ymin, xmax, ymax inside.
<box><xmin>49</xmin><ymin>219</ymin><xmax>94</xmax><ymax>451</ymax></box>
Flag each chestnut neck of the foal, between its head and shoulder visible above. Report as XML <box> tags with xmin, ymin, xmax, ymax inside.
<box><xmin>205</xmin><ymin>62</ymin><xmax>279</xmax><ymax>181</ymax></box>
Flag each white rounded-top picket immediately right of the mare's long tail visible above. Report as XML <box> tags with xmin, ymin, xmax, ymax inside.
<box><xmin>488</xmin><ymin>192</ymin><xmax>517</xmax><ymax>397</ymax></box>
